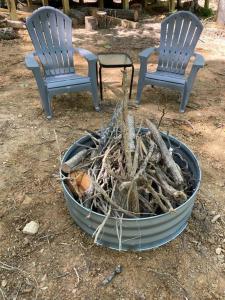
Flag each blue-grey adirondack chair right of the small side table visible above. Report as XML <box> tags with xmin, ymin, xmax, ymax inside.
<box><xmin>136</xmin><ymin>11</ymin><xmax>204</xmax><ymax>112</ymax></box>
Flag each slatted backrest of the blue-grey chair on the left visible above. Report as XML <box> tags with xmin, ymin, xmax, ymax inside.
<box><xmin>26</xmin><ymin>6</ymin><xmax>74</xmax><ymax>76</ymax></box>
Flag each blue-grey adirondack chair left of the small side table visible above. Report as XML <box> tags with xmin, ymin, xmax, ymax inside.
<box><xmin>25</xmin><ymin>6</ymin><xmax>99</xmax><ymax>119</ymax></box>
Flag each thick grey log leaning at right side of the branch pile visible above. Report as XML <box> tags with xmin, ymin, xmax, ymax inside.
<box><xmin>146</xmin><ymin>120</ymin><xmax>184</xmax><ymax>186</ymax></box>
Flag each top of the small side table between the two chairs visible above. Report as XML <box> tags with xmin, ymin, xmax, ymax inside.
<box><xmin>98</xmin><ymin>53</ymin><xmax>132</xmax><ymax>67</ymax></box>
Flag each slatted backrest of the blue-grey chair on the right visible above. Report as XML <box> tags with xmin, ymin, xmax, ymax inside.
<box><xmin>157</xmin><ymin>11</ymin><xmax>203</xmax><ymax>74</ymax></box>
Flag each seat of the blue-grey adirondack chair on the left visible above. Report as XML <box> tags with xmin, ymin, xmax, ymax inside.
<box><xmin>45</xmin><ymin>73</ymin><xmax>91</xmax><ymax>90</ymax></box>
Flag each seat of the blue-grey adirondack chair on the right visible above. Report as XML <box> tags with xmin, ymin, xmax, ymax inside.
<box><xmin>145</xmin><ymin>71</ymin><xmax>186</xmax><ymax>85</ymax></box>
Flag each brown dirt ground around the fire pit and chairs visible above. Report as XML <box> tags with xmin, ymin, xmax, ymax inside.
<box><xmin>0</xmin><ymin>12</ymin><xmax>225</xmax><ymax>300</ymax></box>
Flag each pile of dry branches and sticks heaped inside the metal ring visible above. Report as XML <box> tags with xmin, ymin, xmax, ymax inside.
<box><xmin>62</xmin><ymin>72</ymin><xmax>192</xmax><ymax>217</ymax></box>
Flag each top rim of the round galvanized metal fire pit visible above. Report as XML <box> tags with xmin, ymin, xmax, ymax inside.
<box><xmin>60</xmin><ymin>128</ymin><xmax>202</xmax><ymax>221</ymax></box>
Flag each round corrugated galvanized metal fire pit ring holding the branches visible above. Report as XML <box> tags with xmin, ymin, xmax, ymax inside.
<box><xmin>61</xmin><ymin>129</ymin><xmax>201</xmax><ymax>251</ymax></box>
